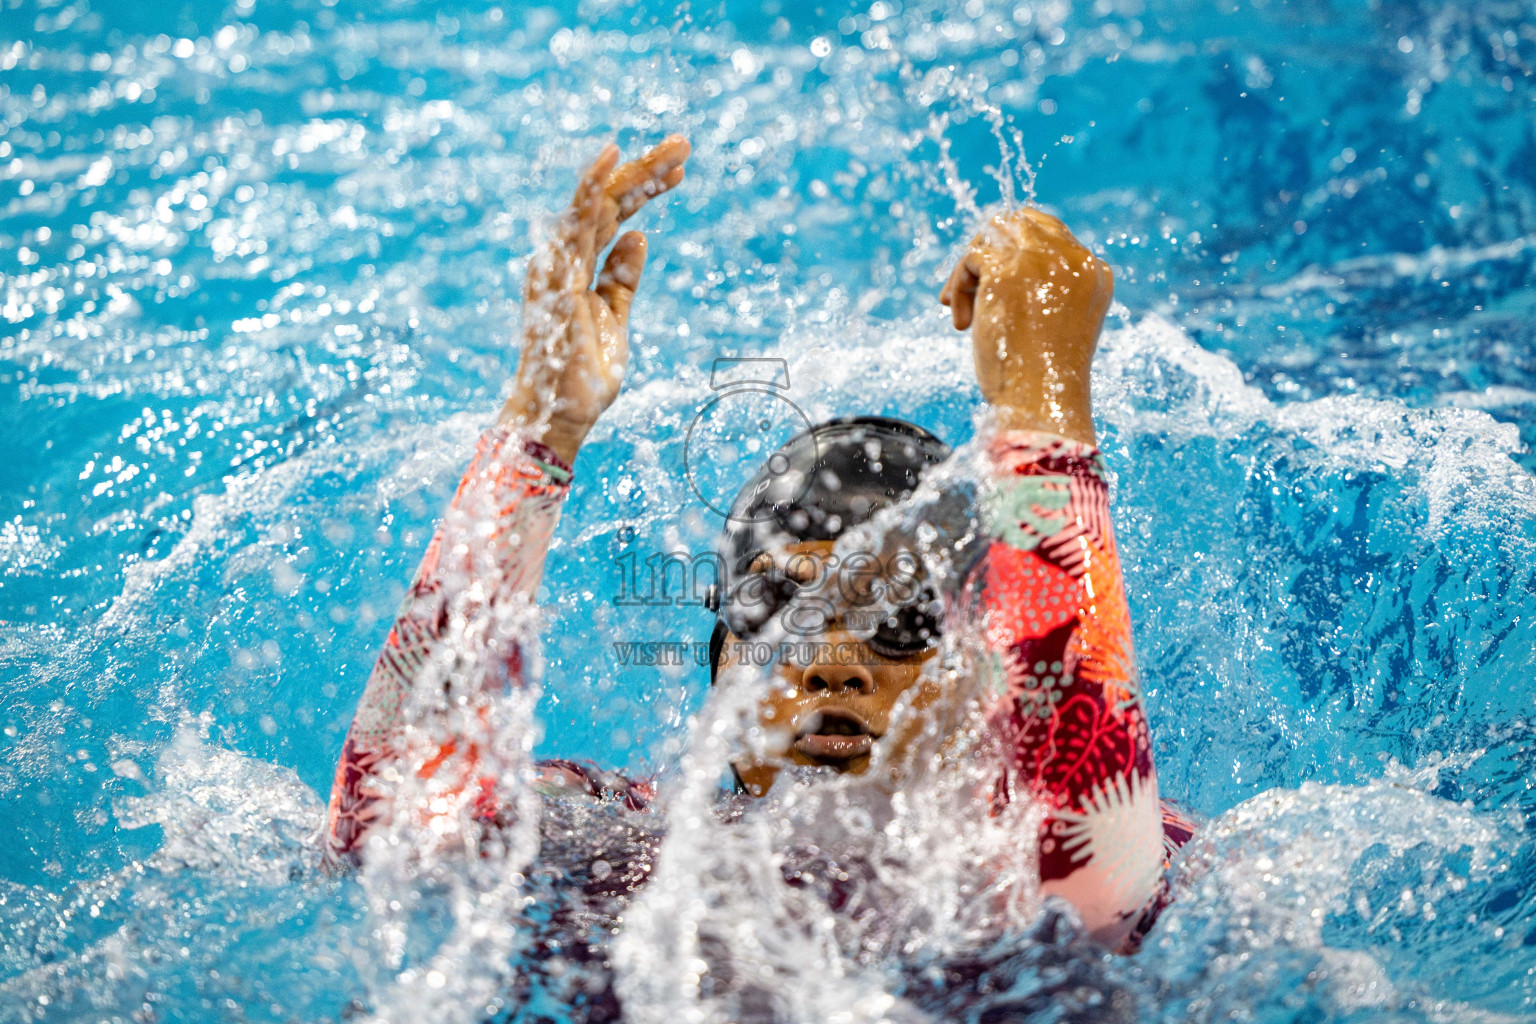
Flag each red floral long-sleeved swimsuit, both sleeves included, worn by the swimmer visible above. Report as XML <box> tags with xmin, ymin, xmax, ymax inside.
<box><xmin>327</xmin><ymin>427</ymin><xmax>1192</xmax><ymax>950</ymax></box>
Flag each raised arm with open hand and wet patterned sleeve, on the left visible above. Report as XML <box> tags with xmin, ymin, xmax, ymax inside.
<box><xmin>326</xmin><ymin>135</ymin><xmax>690</xmax><ymax>863</ymax></box>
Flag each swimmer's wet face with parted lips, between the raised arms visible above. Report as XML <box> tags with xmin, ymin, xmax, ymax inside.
<box><xmin>720</xmin><ymin>540</ymin><xmax>938</xmax><ymax>797</ymax></box>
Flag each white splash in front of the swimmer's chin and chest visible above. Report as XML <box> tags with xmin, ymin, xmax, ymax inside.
<box><xmin>614</xmin><ymin>540</ymin><xmax>1040</xmax><ymax>1024</ymax></box>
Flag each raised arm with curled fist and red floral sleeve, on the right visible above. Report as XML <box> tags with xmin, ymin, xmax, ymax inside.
<box><xmin>940</xmin><ymin>209</ymin><xmax>1163</xmax><ymax>946</ymax></box>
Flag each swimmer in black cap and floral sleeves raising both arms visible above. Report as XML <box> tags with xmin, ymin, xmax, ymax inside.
<box><xmin>327</xmin><ymin>137</ymin><xmax>1189</xmax><ymax>950</ymax></box>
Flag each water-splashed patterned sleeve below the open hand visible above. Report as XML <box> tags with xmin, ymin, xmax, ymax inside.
<box><xmin>326</xmin><ymin>425</ymin><xmax>571</xmax><ymax>861</ymax></box>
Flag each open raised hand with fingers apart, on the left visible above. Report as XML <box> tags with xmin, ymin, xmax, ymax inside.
<box><xmin>501</xmin><ymin>135</ymin><xmax>690</xmax><ymax>462</ymax></box>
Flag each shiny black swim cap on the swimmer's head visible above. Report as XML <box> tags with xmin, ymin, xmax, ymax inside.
<box><xmin>710</xmin><ymin>416</ymin><xmax>949</xmax><ymax>682</ymax></box>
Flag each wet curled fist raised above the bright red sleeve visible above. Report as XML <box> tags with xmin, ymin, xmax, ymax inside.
<box><xmin>938</xmin><ymin>207</ymin><xmax>1115</xmax><ymax>444</ymax></box>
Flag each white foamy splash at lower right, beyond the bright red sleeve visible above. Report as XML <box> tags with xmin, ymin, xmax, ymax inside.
<box><xmin>1147</xmin><ymin>766</ymin><xmax>1518</xmax><ymax>1021</ymax></box>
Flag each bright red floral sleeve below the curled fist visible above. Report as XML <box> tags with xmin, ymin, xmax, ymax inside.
<box><xmin>965</xmin><ymin>431</ymin><xmax>1166</xmax><ymax>944</ymax></box>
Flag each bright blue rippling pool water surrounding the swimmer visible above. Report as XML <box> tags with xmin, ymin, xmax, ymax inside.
<box><xmin>0</xmin><ymin>0</ymin><xmax>1536</xmax><ymax>1022</ymax></box>
